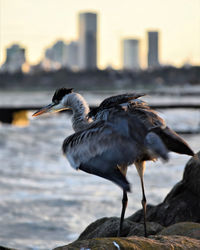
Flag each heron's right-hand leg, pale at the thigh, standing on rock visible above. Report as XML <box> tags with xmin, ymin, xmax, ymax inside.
<box><xmin>135</xmin><ymin>161</ymin><xmax>147</xmax><ymax>237</ymax></box>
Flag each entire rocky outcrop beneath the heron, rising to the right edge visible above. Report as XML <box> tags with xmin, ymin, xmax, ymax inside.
<box><xmin>56</xmin><ymin>152</ymin><xmax>200</xmax><ymax>250</ymax></box>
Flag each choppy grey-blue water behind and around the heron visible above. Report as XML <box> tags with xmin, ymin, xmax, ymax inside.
<box><xmin>0</xmin><ymin>93</ymin><xmax>200</xmax><ymax>250</ymax></box>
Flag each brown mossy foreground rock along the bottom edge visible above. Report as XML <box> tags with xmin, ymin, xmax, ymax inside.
<box><xmin>54</xmin><ymin>235</ymin><xmax>200</xmax><ymax>250</ymax></box>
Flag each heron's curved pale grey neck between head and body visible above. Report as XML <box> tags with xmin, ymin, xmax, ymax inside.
<box><xmin>68</xmin><ymin>93</ymin><xmax>90</xmax><ymax>132</ymax></box>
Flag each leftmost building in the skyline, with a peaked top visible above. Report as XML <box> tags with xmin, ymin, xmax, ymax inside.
<box><xmin>1</xmin><ymin>44</ymin><xmax>26</xmax><ymax>73</ymax></box>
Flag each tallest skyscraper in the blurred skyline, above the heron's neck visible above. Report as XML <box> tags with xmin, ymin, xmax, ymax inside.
<box><xmin>78</xmin><ymin>12</ymin><xmax>97</xmax><ymax>70</ymax></box>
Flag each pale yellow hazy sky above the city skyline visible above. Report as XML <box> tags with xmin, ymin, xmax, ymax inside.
<box><xmin>0</xmin><ymin>0</ymin><xmax>200</xmax><ymax>67</ymax></box>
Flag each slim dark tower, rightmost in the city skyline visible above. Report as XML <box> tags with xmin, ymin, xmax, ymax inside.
<box><xmin>148</xmin><ymin>31</ymin><xmax>160</xmax><ymax>68</ymax></box>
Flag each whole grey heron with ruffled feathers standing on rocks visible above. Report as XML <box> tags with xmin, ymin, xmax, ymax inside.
<box><xmin>33</xmin><ymin>88</ymin><xmax>194</xmax><ymax>237</ymax></box>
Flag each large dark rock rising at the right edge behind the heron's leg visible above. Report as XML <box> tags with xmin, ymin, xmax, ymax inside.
<box><xmin>128</xmin><ymin>152</ymin><xmax>200</xmax><ymax>227</ymax></box>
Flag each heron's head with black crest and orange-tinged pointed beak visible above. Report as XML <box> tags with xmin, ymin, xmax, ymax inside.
<box><xmin>32</xmin><ymin>88</ymin><xmax>73</xmax><ymax>116</ymax></box>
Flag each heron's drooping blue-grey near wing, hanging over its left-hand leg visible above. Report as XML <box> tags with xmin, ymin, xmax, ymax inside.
<box><xmin>63</xmin><ymin>117</ymin><xmax>142</xmax><ymax>191</ymax></box>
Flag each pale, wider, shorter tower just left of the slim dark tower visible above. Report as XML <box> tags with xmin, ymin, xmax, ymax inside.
<box><xmin>123</xmin><ymin>39</ymin><xmax>140</xmax><ymax>70</ymax></box>
